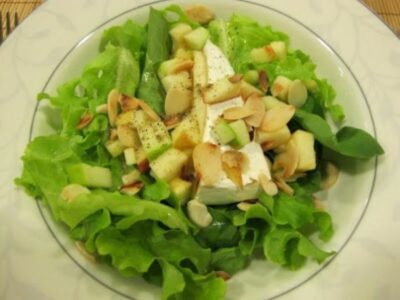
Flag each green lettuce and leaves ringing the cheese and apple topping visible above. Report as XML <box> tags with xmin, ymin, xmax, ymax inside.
<box><xmin>16</xmin><ymin>6</ymin><xmax>383</xmax><ymax>299</ymax></box>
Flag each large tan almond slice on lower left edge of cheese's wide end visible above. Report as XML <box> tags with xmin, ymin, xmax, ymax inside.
<box><xmin>193</xmin><ymin>143</ymin><xmax>223</xmax><ymax>186</ymax></box>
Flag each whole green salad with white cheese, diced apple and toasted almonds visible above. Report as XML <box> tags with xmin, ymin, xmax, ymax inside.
<box><xmin>15</xmin><ymin>5</ymin><xmax>383</xmax><ymax>300</ymax></box>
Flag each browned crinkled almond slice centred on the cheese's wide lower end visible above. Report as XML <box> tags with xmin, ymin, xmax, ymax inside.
<box><xmin>221</xmin><ymin>150</ymin><xmax>246</xmax><ymax>188</ymax></box>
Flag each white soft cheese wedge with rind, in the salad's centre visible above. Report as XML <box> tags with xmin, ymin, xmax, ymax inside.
<box><xmin>197</xmin><ymin>41</ymin><xmax>271</xmax><ymax>205</ymax></box>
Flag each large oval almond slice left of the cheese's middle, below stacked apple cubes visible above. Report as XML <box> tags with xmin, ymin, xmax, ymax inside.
<box><xmin>165</xmin><ymin>86</ymin><xmax>193</xmax><ymax>116</ymax></box>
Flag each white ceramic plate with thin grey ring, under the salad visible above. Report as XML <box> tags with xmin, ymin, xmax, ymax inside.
<box><xmin>0</xmin><ymin>0</ymin><xmax>400</xmax><ymax>300</ymax></box>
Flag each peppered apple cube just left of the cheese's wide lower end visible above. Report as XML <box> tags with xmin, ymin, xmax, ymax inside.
<box><xmin>150</xmin><ymin>148</ymin><xmax>188</xmax><ymax>181</ymax></box>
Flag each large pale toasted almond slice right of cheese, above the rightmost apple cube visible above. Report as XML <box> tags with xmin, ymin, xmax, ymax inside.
<box><xmin>260</xmin><ymin>105</ymin><xmax>296</xmax><ymax>132</ymax></box>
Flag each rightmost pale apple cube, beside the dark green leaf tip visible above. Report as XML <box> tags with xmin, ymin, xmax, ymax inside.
<box><xmin>291</xmin><ymin>129</ymin><xmax>316</xmax><ymax>172</ymax></box>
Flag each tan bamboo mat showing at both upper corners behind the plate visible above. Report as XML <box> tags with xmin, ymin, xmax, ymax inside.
<box><xmin>0</xmin><ymin>0</ymin><xmax>400</xmax><ymax>36</ymax></box>
